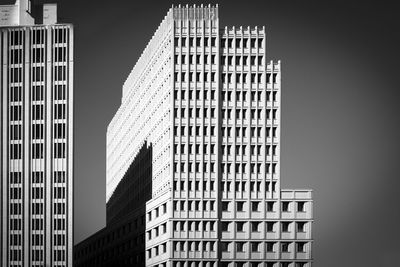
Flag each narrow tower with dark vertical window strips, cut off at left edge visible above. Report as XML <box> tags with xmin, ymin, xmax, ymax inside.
<box><xmin>0</xmin><ymin>0</ymin><xmax>73</xmax><ymax>267</ymax></box>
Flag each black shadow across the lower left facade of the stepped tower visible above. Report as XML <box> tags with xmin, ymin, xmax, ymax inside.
<box><xmin>74</xmin><ymin>142</ymin><xmax>152</xmax><ymax>267</ymax></box>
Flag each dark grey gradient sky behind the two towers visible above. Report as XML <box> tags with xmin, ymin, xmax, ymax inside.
<box><xmin>24</xmin><ymin>0</ymin><xmax>400</xmax><ymax>267</ymax></box>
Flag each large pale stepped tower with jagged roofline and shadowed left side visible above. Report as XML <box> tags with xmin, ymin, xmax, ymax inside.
<box><xmin>75</xmin><ymin>6</ymin><xmax>312</xmax><ymax>267</ymax></box>
